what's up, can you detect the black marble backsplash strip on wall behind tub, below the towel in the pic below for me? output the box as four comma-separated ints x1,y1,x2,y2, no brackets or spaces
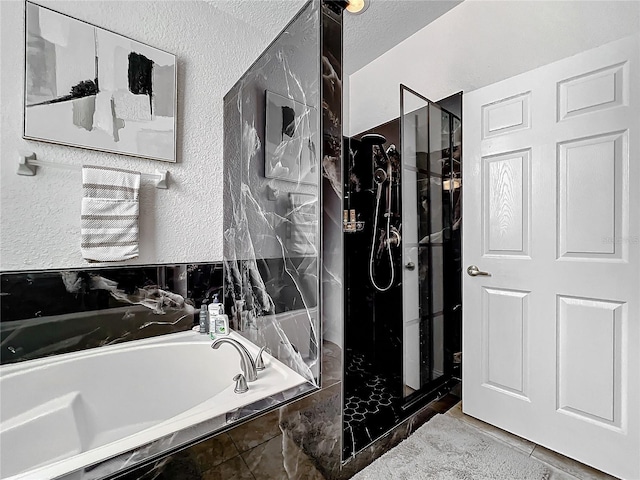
0,262,222,364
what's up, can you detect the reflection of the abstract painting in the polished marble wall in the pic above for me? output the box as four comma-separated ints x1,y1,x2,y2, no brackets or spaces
264,91,319,185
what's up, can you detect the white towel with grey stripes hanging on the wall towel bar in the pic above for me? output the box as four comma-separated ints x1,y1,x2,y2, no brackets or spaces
81,165,140,262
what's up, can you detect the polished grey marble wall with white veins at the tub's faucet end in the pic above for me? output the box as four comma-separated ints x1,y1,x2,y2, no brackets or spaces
224,2,322,384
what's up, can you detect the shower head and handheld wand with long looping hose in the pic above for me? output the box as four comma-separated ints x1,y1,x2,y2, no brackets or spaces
360,133,395,292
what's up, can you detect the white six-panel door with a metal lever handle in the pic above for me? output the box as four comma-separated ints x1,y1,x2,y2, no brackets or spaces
463,36,640,480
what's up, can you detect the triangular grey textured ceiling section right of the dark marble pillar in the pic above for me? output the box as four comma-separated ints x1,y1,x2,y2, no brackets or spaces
344,0,461,75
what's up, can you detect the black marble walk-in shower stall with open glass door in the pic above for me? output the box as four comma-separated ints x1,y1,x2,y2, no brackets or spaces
343,85,462,461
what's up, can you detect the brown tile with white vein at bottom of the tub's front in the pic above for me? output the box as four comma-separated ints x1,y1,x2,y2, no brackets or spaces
242,435,324,480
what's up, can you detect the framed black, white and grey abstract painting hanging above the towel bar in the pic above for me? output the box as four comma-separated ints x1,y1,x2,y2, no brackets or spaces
24,2,176,162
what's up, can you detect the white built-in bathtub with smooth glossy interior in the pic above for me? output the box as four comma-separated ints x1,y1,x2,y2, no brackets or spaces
0,332,306,480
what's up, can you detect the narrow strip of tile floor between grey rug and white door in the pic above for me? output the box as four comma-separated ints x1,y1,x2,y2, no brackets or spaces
445,403,616,480
